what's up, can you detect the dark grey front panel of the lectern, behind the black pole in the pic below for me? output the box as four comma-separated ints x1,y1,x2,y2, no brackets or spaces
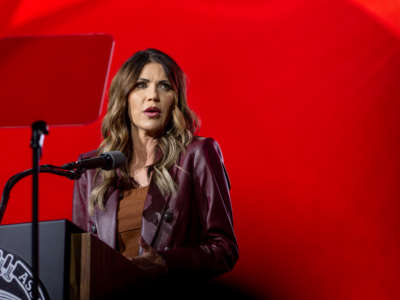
0,220,83,300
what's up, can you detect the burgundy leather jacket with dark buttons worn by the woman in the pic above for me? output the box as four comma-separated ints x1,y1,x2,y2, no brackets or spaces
72,137,238,275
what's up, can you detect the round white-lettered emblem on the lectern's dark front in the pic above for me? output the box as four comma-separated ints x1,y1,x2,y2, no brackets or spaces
0,249,48,300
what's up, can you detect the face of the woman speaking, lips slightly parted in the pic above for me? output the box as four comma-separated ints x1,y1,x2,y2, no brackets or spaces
128,62,175,136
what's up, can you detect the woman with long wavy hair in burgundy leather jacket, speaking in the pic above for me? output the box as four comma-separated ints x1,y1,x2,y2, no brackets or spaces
73,49,238,277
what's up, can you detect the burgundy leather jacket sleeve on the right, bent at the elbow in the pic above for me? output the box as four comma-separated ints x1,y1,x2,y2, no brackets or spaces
161,138,238,276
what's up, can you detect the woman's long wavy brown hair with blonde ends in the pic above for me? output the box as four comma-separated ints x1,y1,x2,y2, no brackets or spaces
89,49,199,214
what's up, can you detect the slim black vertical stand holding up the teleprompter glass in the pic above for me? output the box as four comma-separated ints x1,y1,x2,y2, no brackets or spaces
31,121,48,300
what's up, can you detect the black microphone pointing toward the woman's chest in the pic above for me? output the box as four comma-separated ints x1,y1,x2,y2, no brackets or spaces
61,151,126,170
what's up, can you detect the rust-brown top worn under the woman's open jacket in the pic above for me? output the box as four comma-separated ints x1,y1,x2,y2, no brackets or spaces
117,186,149,258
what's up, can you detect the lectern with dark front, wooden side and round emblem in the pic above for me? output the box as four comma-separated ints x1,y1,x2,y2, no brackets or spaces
0,220,147,300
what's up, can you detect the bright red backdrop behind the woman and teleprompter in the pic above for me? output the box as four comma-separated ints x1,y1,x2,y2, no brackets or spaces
0,0,400,299
